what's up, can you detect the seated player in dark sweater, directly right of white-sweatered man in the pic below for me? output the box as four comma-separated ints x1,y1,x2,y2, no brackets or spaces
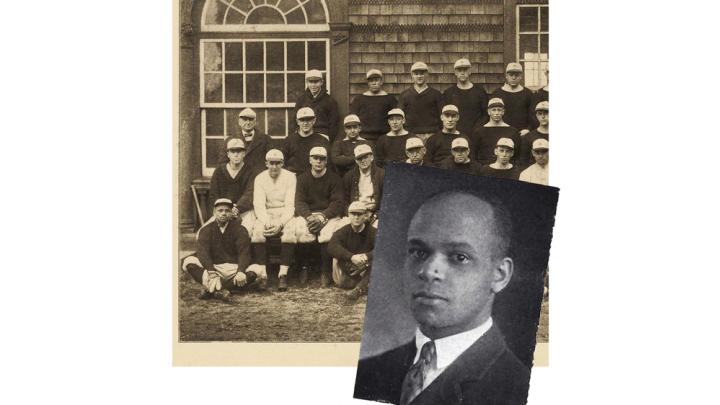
295,146,345,287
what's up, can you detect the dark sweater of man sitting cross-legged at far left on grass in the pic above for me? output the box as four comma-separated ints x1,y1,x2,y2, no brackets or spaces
197,220,252,271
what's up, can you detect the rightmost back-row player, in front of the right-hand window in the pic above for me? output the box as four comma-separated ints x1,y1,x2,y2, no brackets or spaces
492,62,533,135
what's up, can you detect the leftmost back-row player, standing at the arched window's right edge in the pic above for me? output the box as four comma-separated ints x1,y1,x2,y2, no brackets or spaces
293,69,340,142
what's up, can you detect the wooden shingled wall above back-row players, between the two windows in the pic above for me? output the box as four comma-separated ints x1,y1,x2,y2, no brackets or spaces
349,0,504,98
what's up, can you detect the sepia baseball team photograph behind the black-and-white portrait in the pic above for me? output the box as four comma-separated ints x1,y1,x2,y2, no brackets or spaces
174,0,554,354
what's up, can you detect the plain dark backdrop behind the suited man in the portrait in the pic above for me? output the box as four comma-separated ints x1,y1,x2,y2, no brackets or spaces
360,163,559,365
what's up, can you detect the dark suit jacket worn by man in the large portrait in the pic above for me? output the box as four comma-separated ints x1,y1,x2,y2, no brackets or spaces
354,326,530,405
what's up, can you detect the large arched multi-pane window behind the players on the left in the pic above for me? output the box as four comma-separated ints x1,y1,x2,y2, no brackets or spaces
199,0,330,176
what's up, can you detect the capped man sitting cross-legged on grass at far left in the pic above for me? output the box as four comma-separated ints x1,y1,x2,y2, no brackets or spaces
182,198,267,301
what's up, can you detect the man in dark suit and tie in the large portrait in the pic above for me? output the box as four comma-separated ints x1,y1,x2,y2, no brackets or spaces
355,191,530,405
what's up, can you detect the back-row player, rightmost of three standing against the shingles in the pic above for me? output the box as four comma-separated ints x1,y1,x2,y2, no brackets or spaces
443,58,488,135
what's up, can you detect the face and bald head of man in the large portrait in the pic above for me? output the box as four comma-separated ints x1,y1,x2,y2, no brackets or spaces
404,195,512,339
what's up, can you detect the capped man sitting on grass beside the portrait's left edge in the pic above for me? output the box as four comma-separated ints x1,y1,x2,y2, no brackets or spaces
328,201,377,303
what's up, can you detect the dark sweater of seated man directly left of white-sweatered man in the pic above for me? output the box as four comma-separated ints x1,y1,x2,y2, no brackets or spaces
207,164,258,213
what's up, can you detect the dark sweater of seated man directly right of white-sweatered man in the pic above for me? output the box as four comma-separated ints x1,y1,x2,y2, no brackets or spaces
295,170,345,219
